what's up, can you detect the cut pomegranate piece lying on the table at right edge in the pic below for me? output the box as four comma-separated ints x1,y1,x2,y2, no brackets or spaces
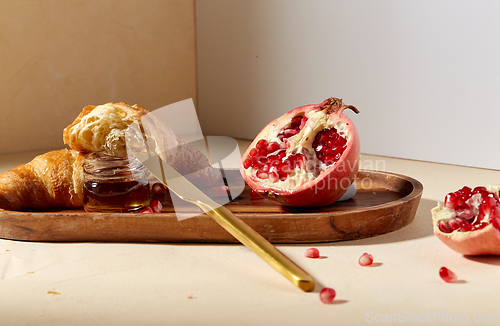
431,186,500,255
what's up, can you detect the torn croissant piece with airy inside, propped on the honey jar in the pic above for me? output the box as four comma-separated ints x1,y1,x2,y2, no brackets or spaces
63,102,222,187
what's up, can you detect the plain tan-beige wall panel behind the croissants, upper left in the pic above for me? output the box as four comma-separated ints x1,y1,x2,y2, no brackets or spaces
0,0,196,154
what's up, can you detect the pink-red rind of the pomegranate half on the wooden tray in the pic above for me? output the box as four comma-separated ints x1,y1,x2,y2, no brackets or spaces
240,99,360,207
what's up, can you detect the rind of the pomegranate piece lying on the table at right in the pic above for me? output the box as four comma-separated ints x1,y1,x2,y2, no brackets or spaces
431,195,500,256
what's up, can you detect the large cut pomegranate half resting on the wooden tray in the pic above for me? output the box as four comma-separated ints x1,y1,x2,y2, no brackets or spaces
240,98,360,207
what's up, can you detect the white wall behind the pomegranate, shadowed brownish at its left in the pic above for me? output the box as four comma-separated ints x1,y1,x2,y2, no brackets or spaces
196,0,500,171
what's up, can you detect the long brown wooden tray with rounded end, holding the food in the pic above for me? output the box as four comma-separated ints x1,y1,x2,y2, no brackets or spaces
0,170,423,243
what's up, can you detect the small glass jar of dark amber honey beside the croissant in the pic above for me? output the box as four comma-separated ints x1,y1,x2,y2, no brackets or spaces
83,152,151,212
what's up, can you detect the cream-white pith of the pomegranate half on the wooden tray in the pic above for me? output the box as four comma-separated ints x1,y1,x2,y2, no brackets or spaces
245,111,351,190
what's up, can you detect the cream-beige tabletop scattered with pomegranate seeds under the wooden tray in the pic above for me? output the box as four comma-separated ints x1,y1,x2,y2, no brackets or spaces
0,142,500,325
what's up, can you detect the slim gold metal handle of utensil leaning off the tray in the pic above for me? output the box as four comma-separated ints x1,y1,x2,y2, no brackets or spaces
193,201,315,292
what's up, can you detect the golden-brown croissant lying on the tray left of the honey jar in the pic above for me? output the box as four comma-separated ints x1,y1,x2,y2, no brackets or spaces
0,149,84,210
